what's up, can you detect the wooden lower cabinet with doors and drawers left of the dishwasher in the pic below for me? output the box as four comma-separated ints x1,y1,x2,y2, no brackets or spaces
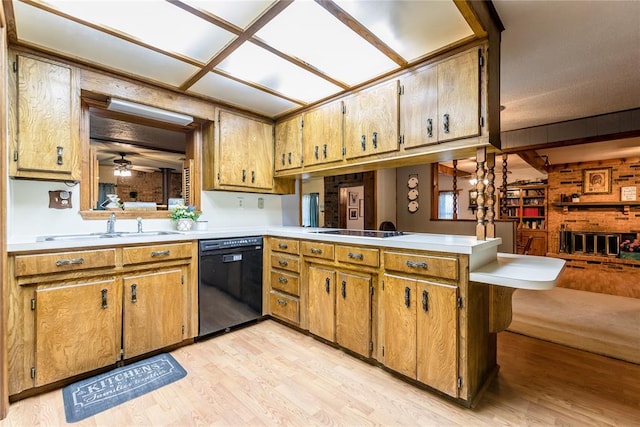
7,242,198,395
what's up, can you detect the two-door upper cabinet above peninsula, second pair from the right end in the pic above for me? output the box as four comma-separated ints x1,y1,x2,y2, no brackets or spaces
344,80,400,159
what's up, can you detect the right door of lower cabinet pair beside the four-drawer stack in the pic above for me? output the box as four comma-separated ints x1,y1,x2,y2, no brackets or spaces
336,272,371,357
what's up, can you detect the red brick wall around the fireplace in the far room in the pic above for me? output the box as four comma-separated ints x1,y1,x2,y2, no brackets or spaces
547,159,640,253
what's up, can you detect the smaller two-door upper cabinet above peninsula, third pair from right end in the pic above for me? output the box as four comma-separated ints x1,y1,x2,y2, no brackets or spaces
302,101,344,166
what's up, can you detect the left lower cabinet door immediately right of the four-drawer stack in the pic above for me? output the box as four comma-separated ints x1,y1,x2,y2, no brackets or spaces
308,265,336,342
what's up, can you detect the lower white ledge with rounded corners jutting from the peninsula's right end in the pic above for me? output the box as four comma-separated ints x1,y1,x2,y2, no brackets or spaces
469,253,565,290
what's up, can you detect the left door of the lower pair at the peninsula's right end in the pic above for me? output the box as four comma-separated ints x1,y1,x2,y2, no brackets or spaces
383,275,417,378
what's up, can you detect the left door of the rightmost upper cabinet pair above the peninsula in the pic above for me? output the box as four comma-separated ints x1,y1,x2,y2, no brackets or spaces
400,66,438,148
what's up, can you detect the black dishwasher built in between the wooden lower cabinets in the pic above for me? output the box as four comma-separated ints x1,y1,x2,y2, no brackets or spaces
198,236,262,338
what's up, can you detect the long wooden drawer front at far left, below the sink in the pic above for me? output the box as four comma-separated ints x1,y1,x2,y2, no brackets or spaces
15,249,116,277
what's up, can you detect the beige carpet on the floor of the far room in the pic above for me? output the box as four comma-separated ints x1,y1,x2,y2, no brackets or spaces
508,288,640,364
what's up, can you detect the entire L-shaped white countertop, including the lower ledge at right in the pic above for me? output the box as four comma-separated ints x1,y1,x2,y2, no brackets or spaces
7,226,564,289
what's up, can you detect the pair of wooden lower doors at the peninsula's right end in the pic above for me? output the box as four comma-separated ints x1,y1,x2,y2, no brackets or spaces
383,274,458,397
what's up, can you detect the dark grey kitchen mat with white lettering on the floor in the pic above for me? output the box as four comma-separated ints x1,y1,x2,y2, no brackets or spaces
62,353,187,423
